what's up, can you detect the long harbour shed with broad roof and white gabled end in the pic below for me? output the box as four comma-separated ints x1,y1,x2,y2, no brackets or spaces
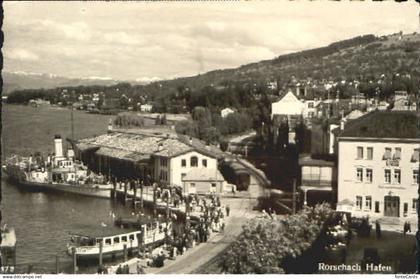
75,128,222,186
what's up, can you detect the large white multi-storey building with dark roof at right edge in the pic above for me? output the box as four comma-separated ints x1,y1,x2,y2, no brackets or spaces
337,111,420,222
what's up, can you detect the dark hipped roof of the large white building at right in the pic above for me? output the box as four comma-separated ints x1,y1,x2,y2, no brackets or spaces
339,111,420,139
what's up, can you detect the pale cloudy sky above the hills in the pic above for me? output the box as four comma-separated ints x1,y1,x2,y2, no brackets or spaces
2,0,420,82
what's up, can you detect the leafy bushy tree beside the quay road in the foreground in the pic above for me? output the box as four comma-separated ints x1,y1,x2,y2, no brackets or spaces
220,204,332,274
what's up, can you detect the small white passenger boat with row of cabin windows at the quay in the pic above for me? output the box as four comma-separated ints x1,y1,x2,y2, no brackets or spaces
67,219,172,261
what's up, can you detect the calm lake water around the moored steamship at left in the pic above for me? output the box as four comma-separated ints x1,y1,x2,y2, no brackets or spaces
0,105,146,273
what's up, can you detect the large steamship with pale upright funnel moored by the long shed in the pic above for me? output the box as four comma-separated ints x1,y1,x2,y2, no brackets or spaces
3,135,112,198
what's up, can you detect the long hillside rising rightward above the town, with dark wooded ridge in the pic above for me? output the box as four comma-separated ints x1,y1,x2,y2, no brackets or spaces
146,33,420,90
